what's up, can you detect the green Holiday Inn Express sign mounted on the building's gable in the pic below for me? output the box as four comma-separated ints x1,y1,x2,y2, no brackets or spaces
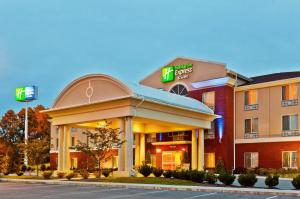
161,63,193,83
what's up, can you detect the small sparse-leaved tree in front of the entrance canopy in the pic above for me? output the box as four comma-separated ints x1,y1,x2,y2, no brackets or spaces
74,122,125,178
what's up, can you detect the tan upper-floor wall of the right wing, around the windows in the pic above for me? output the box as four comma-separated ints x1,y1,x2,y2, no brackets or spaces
236,83,300,139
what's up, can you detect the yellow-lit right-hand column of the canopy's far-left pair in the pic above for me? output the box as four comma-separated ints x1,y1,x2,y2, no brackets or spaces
63,126,71,171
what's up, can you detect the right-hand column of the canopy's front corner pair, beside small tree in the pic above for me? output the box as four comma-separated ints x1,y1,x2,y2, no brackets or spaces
125,117,133,171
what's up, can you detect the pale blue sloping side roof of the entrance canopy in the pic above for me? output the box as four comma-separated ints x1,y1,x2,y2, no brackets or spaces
122,81,214,114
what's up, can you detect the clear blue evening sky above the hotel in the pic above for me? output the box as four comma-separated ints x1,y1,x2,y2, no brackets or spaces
0,0,300,116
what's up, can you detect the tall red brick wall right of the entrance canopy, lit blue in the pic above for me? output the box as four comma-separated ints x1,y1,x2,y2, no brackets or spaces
189,85,234,169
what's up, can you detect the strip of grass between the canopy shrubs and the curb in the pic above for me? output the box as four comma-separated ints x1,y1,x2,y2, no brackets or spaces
81,177,203,186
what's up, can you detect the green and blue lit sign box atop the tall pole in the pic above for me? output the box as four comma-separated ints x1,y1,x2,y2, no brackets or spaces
16,86,37,102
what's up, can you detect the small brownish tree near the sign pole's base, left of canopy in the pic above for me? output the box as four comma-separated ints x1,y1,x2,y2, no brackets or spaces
18,138,50,176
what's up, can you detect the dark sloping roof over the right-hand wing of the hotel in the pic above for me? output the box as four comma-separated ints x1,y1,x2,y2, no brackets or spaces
245,71,300,85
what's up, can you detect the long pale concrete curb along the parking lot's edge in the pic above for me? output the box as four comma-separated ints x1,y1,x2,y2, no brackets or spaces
0,178,300,196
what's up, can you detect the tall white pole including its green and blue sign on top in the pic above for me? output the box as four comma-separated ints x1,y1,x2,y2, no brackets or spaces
15,86,37,166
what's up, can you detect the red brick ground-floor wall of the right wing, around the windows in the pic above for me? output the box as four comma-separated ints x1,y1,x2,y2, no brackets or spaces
236,141,300,169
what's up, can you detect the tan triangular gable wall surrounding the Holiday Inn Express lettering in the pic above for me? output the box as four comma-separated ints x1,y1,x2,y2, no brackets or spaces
140,58,227,91
